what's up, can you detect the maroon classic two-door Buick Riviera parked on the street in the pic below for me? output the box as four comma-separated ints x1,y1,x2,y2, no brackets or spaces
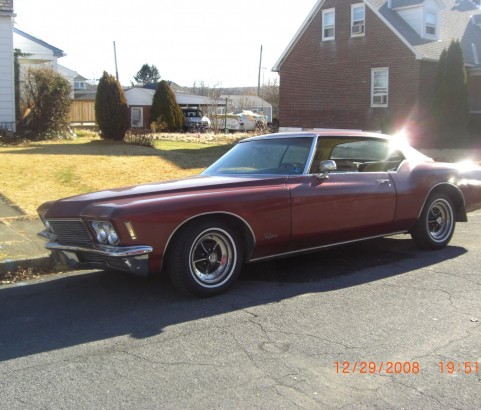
38,130,481,296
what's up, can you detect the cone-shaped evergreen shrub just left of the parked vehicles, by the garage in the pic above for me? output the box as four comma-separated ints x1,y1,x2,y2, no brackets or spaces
152,80,184,131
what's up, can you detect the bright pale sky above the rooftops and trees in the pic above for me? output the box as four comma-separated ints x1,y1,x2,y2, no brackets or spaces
14,0,317,87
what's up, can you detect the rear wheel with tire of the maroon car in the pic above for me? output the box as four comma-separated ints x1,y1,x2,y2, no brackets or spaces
411,194,456,249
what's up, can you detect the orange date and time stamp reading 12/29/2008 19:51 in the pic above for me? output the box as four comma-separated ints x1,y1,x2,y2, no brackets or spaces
334,361,479,374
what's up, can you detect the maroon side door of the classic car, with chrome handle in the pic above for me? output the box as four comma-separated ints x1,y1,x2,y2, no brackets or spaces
288,138,396,250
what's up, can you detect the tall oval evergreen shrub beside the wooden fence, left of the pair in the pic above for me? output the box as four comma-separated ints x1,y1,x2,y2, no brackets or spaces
95,71,129,140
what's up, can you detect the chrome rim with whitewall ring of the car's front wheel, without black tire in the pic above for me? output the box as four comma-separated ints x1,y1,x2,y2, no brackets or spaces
189,229,237,286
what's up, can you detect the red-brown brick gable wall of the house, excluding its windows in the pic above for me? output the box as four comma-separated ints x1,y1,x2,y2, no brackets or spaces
279,0,436,139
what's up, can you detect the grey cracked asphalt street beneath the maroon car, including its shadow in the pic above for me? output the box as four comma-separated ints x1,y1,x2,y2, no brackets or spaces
0,211,481,409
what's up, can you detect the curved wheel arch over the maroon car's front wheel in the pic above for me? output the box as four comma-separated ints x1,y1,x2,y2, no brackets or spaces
164,213,255,260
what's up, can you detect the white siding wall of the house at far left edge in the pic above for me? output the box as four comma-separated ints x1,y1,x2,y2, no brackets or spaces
0,0,15,133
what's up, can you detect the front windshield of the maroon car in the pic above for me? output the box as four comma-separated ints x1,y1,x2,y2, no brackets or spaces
202,137,313,175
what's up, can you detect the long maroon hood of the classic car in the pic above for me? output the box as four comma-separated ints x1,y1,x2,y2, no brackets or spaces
38,176,286,218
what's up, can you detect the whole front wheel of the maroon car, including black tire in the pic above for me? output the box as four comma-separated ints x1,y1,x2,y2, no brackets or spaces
167,221,242,296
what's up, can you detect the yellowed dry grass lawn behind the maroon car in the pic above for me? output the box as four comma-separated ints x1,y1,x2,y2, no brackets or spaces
0,135,236,216
